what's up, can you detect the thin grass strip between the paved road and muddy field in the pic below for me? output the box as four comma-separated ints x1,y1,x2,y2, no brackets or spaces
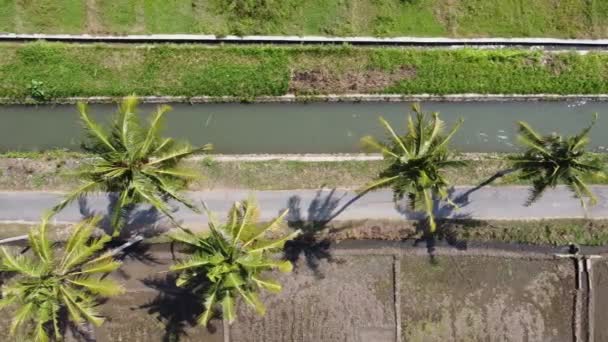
0,219,608,247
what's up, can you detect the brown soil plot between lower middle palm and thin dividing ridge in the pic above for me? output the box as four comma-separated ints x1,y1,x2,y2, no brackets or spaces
230,255,395,342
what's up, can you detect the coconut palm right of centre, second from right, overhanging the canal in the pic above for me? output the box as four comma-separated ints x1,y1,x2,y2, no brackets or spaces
360,104,464,232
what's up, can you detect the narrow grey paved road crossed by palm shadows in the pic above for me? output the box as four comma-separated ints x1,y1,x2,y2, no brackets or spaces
0,186,608,225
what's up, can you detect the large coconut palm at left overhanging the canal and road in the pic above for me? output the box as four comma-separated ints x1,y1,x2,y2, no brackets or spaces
53,96,211,236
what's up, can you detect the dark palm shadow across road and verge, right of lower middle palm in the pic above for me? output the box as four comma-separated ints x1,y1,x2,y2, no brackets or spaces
284,189,353,278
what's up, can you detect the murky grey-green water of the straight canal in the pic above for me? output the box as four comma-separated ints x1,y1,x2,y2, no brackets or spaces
0,101,608,154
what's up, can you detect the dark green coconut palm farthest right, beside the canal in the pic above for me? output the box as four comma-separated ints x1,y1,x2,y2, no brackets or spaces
510,114,605,208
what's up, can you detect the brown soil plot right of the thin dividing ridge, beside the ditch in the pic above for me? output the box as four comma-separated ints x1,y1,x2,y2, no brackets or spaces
400,256,575,342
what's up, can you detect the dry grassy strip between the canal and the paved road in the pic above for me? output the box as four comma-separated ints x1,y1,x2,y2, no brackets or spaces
0,151,608,191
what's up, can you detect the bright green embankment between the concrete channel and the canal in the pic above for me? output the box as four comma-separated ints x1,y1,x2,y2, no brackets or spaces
0,43,608,100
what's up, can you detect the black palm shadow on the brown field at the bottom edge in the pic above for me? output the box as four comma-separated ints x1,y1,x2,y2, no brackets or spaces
136,274,218,342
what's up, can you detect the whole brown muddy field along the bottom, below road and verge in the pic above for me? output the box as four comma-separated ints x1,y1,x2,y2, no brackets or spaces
2,243,592,342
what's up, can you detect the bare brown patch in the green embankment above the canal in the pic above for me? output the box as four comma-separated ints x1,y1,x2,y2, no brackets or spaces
289,67,416,94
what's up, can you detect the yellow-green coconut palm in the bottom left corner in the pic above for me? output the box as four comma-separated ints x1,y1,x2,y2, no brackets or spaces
0,218,123,341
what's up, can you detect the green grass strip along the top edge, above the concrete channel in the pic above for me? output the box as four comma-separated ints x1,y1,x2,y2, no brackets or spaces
0,0,608,37
